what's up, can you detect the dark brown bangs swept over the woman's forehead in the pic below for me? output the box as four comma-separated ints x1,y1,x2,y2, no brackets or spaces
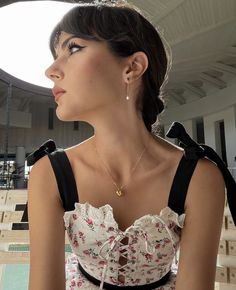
49,4,143,58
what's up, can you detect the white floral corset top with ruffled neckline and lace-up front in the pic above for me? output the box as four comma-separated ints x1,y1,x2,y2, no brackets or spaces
64,203,185,289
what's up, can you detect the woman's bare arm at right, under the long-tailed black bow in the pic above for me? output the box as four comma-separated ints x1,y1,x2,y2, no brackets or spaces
176,159,225,290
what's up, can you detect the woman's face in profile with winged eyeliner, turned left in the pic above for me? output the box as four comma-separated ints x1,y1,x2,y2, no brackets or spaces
46,32,126,121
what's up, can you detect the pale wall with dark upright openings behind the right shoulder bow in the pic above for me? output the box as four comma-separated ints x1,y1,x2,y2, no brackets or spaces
161,81,236,167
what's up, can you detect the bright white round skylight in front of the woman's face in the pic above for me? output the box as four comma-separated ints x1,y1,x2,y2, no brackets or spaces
0,1,76,88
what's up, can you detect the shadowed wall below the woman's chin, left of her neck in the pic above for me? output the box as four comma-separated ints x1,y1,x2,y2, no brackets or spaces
0,103,93,153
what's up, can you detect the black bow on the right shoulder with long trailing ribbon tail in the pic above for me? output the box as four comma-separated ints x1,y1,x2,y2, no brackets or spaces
166,122,236,225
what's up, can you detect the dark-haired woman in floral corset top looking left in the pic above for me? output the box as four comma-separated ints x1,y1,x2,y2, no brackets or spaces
28,4,225,290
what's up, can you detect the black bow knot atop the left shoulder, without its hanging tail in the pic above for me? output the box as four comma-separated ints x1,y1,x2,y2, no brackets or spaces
27,139,56,166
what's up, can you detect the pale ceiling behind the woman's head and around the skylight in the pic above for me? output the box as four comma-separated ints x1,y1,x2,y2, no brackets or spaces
0,0,236,110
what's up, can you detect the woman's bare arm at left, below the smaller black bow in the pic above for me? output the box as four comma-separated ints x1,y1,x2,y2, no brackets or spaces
28,156,65,290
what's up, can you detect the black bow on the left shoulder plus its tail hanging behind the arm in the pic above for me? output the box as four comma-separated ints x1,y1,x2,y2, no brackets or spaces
21,139,56,222
